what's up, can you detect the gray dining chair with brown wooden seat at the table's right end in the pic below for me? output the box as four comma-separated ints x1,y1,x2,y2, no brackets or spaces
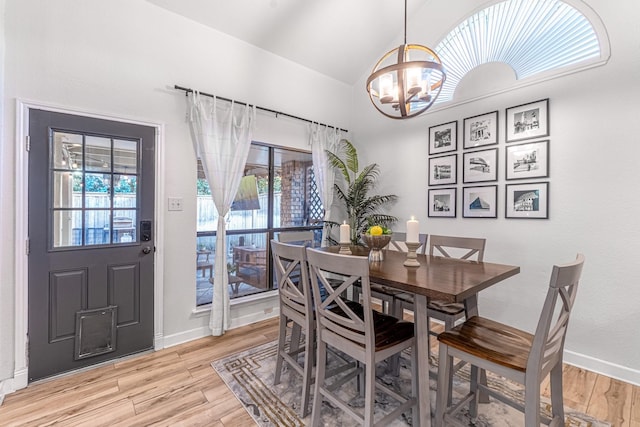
435,254,584,427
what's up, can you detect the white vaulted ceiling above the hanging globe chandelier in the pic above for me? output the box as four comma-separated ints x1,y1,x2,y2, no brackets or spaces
147,0,429,85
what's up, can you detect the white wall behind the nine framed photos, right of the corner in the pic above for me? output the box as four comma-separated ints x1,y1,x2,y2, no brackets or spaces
351,0,640,384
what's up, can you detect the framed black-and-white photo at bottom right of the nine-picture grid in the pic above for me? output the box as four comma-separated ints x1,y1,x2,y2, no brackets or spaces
505,182,549,219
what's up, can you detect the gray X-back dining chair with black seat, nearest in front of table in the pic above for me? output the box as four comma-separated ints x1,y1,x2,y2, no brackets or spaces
307,248,417,426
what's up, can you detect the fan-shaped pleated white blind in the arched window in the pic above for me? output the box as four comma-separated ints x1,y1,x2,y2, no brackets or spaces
435,0,601,103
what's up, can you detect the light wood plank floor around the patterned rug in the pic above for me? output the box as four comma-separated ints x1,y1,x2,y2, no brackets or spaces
0,319,640,427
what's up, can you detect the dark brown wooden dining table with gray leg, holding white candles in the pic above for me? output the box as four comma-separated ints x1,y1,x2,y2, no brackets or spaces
325,246,520,426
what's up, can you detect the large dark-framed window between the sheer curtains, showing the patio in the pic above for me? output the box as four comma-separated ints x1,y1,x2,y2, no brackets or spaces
196,143,324,305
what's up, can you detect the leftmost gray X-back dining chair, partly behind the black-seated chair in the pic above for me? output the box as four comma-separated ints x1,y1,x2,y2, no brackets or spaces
271,240,316,418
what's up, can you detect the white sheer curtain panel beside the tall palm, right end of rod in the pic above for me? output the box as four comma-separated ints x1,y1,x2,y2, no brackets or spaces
309,123,342,246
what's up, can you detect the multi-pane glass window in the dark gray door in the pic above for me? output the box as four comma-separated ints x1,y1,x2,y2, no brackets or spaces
50,130,139,248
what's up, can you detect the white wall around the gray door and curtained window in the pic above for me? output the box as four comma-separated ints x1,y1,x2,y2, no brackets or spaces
0,0,351,386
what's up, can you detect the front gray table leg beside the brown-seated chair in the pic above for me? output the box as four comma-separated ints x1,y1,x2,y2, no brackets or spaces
413,294,431,427
